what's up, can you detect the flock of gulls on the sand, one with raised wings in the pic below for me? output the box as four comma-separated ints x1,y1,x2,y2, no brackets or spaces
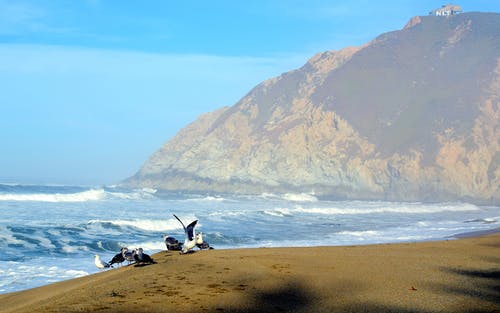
94,214,213,270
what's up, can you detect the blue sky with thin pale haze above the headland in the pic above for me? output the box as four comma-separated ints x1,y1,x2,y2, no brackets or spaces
0,0,500,186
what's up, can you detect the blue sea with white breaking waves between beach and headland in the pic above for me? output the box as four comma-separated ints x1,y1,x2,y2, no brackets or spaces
0,184,500,293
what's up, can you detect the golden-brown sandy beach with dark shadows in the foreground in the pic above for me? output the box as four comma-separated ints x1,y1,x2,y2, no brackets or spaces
0,233,500,313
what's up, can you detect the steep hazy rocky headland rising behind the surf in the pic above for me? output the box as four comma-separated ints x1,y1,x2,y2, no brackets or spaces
125,13,500,204
